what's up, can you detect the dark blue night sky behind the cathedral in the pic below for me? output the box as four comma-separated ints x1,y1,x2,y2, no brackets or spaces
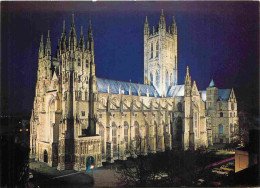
1,1,259,115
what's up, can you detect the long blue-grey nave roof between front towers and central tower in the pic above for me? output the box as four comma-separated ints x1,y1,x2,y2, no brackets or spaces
97,78,159,97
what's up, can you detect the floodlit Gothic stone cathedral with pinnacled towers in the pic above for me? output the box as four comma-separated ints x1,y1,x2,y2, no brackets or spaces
30,11,238,171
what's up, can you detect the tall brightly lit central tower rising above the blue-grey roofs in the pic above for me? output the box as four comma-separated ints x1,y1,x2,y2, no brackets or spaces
144,10,178,97
